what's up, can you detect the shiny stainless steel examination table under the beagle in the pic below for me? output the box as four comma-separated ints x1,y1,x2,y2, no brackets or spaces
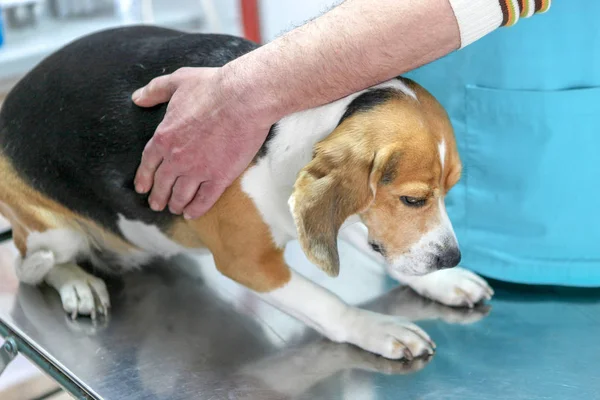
0,233,600,400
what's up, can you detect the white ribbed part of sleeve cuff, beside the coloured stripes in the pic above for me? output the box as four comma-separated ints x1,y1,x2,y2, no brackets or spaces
450,0,504,49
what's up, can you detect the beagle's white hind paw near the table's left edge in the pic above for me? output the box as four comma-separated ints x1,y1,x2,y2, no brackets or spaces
46,264,110,319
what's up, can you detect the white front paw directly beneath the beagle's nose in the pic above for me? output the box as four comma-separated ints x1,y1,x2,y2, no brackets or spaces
399,267,494,308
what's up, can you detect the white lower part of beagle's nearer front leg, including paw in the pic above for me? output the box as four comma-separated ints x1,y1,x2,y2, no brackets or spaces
262,272,435,359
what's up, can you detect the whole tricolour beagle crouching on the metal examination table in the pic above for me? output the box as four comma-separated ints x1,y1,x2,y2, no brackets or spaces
0,26,492,359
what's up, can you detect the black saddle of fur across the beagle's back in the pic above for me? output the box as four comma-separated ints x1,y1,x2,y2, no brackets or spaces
0,26,258,234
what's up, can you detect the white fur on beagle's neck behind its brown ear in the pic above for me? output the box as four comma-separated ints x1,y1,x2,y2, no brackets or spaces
242,79,416,247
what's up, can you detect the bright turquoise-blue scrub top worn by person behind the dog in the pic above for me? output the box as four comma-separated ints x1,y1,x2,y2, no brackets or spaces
407,0,600,286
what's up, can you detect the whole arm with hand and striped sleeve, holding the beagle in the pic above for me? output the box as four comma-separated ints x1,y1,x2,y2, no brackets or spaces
133,0,549,218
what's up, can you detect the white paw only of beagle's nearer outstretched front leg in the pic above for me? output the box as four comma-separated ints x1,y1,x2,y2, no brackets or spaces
346,308,435,360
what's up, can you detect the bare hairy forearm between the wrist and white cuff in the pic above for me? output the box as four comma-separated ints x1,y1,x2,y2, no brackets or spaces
224,0,460,122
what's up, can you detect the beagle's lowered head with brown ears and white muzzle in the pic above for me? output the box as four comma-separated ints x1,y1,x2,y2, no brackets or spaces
290,80,461,276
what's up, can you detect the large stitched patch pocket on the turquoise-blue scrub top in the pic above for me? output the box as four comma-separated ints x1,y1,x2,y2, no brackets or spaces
460,86,600,286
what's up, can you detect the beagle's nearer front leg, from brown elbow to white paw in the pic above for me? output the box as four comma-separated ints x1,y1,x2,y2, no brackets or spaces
213,244,434,359
